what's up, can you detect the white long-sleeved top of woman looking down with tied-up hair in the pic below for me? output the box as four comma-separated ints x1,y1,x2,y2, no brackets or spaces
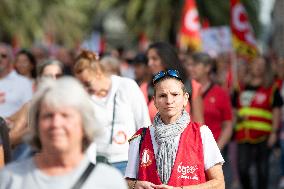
88,76,151,163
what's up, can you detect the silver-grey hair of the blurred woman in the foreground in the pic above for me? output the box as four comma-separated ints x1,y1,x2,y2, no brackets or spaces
29,77,99,151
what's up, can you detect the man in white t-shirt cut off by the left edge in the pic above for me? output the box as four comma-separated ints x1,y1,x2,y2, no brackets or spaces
0,43,32,118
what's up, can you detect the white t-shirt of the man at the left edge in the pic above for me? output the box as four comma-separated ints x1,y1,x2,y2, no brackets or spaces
0,71,33,117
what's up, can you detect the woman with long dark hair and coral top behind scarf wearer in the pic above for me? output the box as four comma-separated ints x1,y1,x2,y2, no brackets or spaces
140,42,204,123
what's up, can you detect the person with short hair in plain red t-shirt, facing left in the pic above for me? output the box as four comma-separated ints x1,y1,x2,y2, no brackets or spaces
187,53,233,150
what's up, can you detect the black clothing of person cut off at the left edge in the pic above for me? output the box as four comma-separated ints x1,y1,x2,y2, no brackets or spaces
0,117,11,164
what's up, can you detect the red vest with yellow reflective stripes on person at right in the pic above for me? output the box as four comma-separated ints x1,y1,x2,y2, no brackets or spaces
235,86,275,143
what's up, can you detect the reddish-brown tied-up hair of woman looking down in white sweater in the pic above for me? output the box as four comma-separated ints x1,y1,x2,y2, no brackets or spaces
74,50,106,74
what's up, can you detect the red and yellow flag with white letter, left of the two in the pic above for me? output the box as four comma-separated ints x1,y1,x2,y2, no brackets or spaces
179,0,201,50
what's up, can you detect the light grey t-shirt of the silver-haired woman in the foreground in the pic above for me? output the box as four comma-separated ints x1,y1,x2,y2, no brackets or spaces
0,157,127,189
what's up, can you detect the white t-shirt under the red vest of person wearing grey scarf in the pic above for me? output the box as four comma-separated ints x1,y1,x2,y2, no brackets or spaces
125,125,224,178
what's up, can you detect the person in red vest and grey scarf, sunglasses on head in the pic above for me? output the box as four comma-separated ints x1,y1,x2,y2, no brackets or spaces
125,70,225,189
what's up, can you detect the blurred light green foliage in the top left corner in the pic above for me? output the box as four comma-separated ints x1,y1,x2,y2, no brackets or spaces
0,0,96,46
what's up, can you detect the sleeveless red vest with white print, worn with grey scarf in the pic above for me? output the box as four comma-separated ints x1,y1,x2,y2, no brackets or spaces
137,123,206,187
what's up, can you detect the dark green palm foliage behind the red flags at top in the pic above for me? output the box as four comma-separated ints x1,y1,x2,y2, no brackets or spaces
96,0,261,41
